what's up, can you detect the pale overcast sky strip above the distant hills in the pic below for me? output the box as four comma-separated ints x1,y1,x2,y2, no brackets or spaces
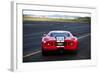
23,10,90,17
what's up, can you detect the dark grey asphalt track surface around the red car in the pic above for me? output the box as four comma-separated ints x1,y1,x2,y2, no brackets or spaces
23,21,91,62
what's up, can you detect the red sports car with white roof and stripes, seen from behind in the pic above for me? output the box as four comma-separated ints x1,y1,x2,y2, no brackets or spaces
42,30,78,55
